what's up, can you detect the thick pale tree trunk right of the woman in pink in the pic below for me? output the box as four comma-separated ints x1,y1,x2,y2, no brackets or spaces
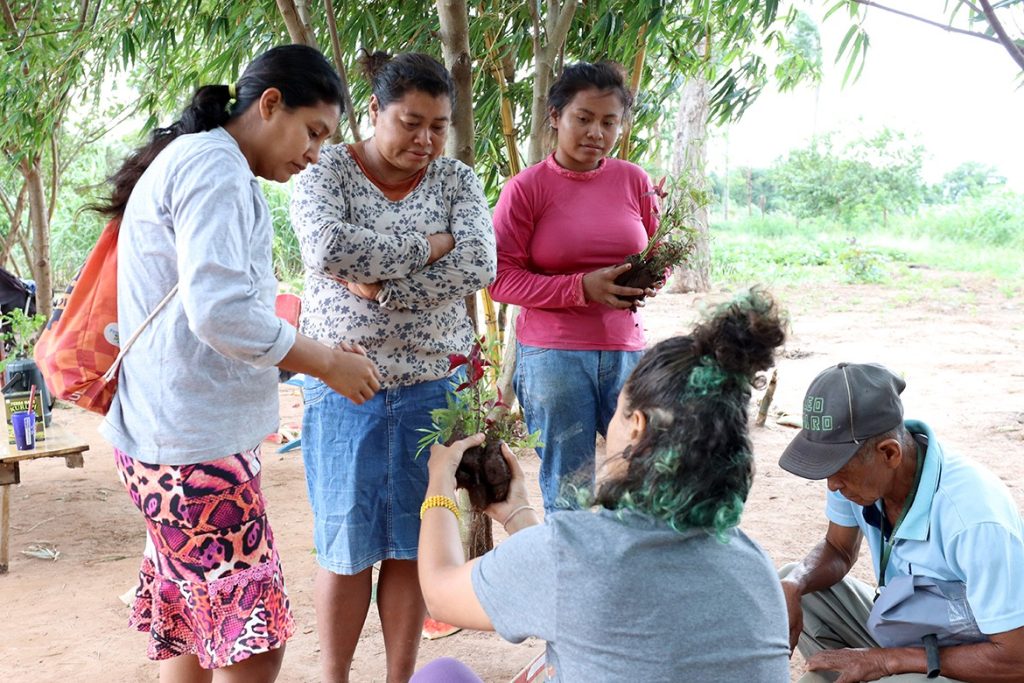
670,70,708,292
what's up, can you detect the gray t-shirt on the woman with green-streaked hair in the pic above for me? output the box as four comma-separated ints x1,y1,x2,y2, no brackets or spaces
472,510,790,683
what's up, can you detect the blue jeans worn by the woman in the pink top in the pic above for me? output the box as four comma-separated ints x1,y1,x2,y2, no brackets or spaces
513,344,643,514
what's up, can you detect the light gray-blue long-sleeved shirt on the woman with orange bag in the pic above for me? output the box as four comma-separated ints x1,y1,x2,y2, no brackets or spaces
100,128,295,465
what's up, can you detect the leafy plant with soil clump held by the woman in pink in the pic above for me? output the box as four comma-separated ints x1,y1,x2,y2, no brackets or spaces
615,177,708,310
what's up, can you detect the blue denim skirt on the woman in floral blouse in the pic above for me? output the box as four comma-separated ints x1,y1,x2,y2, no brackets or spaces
302,376,453,574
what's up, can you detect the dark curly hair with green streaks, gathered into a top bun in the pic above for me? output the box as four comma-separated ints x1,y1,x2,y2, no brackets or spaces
581,289,785,539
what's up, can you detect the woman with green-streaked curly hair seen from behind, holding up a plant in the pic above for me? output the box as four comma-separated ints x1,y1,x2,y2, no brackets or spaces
414,289,790,683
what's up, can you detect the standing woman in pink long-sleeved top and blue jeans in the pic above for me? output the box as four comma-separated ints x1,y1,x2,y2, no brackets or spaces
489,62,657,513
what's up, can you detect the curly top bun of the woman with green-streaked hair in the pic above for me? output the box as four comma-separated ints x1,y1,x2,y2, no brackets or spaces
693,287,786,378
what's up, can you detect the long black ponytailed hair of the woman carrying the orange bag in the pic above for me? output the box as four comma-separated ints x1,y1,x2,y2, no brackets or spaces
92,45,344,218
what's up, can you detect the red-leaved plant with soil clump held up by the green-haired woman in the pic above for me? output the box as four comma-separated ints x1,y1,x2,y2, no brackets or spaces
417,338,542,512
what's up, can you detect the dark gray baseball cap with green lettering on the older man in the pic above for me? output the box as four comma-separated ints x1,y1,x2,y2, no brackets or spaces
778,362,906,479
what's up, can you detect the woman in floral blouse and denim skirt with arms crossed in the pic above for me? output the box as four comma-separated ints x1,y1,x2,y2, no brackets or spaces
292,52,497,681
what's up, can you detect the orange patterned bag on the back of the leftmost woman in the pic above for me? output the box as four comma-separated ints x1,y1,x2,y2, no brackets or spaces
35,219,178,415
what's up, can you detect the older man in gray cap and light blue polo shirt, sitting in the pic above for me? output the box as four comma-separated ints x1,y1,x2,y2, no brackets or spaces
779,362,1024,683
